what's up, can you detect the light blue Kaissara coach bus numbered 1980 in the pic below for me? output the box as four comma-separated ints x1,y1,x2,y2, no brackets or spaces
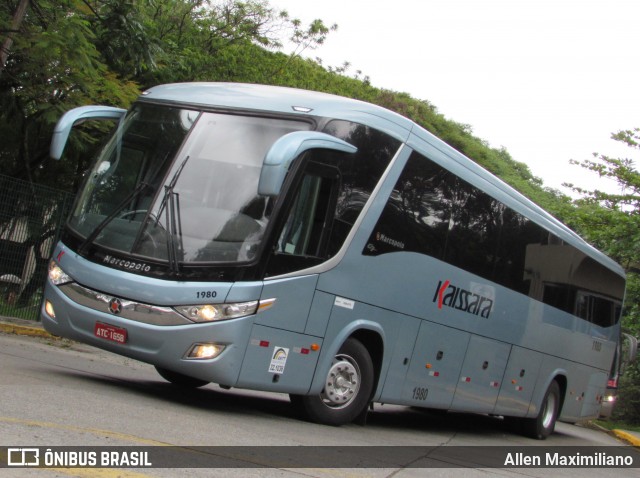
42,83,625,439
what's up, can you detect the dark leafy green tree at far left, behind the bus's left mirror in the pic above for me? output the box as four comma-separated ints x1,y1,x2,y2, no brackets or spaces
0,0,137,186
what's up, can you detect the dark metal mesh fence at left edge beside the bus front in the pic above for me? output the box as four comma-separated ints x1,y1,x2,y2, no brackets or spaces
0,175,73,320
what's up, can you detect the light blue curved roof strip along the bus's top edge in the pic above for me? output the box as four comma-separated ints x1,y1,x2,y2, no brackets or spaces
140,82,625,277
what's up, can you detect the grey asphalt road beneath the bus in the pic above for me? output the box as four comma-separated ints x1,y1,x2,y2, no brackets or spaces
0,334,640,478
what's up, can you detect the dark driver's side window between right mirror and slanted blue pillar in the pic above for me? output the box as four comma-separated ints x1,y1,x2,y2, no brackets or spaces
266,120,400,276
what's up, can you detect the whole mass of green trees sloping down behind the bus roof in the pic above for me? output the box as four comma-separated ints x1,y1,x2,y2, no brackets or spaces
0,0,562,206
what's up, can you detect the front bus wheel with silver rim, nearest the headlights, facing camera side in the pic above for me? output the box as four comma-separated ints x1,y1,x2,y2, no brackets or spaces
291,338,374,426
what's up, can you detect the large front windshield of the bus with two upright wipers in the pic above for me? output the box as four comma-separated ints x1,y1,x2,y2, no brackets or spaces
69,104,309,265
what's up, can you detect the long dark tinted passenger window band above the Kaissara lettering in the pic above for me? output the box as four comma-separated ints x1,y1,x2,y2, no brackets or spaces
363,153,624,327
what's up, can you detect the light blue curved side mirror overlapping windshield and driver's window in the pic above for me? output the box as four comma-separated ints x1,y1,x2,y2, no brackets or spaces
258,131,358,196
